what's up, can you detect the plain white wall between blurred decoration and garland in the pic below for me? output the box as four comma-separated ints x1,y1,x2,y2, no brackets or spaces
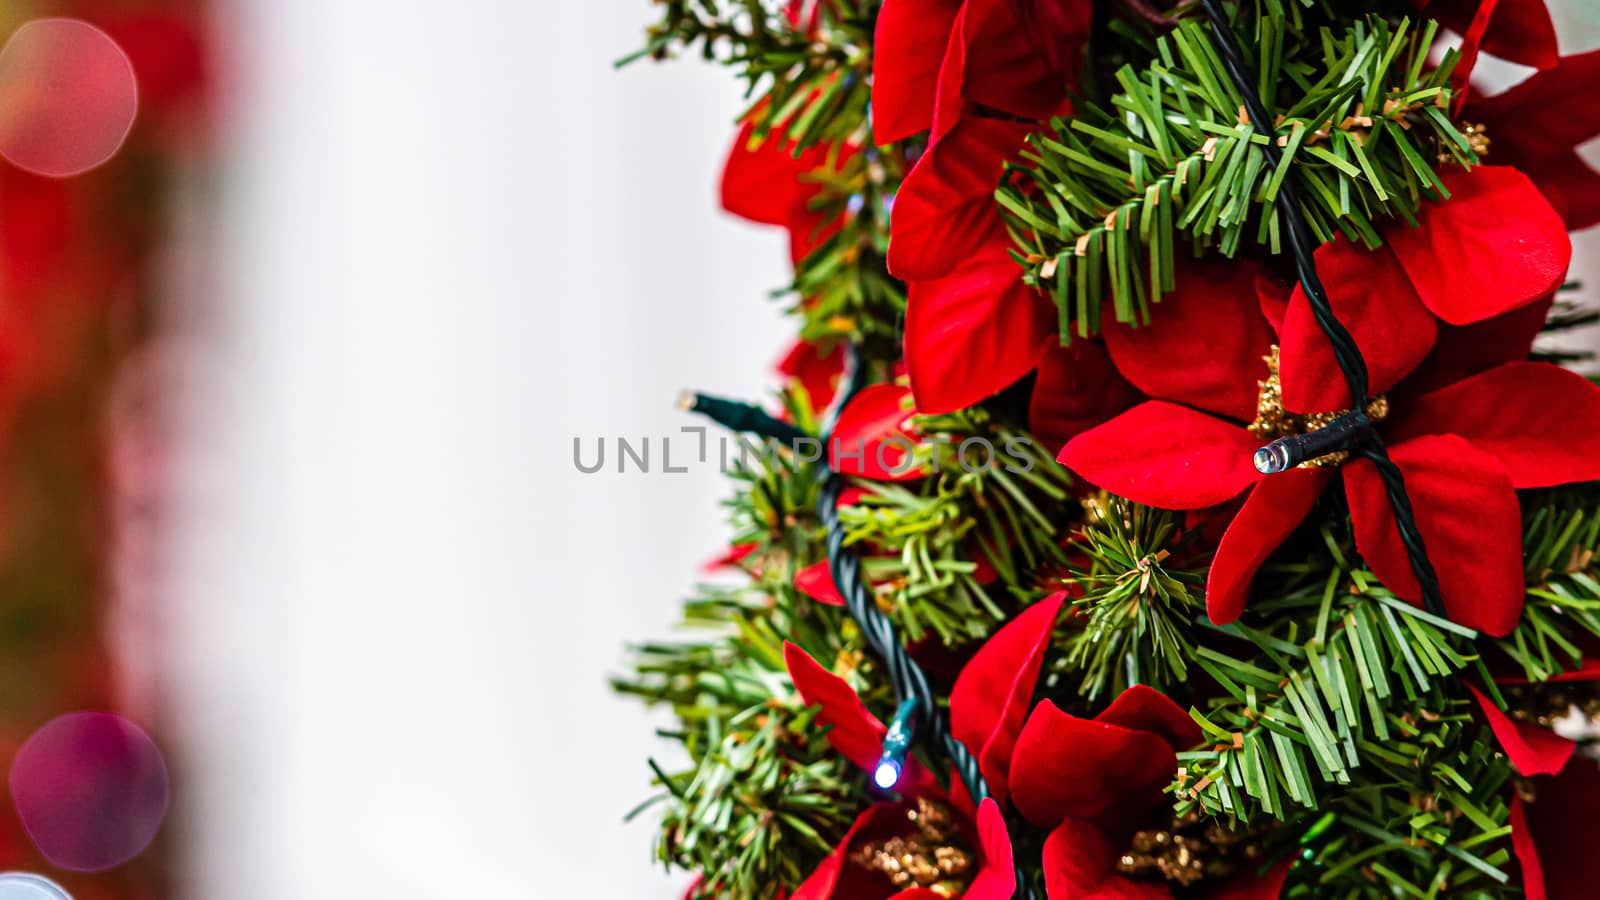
162,0,1600,900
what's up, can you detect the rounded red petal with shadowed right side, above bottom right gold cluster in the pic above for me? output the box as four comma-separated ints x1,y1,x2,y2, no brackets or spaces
1011,700,1178,828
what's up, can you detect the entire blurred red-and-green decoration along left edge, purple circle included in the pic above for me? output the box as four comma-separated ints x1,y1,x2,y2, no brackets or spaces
0,0,210,900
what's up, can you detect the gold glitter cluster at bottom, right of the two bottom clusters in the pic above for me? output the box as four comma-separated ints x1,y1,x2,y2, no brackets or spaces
1117,812,1261,887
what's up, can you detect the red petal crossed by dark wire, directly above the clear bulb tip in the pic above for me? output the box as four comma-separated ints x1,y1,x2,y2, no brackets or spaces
1278,239,1443,413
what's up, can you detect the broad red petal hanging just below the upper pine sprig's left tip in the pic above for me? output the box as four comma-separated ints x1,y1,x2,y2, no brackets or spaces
906,231,1054,413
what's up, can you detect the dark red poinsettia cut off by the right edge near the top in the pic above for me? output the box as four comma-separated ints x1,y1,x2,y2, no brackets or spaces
1461,50,1600,231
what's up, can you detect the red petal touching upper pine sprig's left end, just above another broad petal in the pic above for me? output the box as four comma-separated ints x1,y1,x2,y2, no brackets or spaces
888,117,1032,282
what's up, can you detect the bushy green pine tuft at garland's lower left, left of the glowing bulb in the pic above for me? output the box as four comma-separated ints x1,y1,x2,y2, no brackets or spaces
613,589,883,900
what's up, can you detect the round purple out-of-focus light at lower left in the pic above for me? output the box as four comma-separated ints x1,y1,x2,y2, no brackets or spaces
11,713,170,871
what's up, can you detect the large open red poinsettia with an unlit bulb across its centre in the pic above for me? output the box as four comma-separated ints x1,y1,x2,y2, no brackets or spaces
1061,168,1600,634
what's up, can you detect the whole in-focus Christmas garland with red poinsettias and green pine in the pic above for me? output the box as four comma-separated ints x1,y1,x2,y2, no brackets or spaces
616,0,1600,900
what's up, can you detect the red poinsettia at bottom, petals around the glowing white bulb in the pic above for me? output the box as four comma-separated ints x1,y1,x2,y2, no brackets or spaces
784,644,1016,900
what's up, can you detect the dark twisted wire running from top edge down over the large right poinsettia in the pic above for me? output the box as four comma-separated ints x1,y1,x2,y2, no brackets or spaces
1202,0,1445,618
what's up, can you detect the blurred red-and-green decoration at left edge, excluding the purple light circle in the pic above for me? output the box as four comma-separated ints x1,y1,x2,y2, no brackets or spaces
0,0,214,900
